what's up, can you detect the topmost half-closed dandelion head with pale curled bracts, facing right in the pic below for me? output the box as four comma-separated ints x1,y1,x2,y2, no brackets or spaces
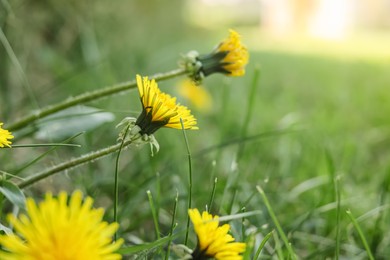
183,30,249,82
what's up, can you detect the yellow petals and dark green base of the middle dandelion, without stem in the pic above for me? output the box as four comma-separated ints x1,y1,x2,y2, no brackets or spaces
135,75,198,135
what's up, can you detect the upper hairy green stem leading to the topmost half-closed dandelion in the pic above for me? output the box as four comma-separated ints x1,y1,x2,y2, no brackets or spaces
7,69,186,131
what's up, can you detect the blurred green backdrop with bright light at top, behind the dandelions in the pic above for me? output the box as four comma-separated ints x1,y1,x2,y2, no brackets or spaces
0,0,390,259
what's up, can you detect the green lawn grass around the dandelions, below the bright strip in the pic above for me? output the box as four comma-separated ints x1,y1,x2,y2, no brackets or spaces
0,1,390,259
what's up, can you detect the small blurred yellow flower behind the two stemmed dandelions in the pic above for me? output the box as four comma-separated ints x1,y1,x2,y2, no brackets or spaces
178,79,212,112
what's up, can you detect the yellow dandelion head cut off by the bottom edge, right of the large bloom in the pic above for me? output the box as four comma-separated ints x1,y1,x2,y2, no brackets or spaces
188,209,246,260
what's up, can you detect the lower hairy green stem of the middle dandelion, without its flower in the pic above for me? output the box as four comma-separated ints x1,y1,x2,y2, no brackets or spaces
18,140,132,189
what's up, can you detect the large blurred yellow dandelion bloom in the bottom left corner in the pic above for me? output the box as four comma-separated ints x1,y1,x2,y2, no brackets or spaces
0,191,122,260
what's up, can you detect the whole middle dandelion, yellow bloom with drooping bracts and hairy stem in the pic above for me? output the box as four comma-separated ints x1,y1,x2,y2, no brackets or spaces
18,75,198,188
